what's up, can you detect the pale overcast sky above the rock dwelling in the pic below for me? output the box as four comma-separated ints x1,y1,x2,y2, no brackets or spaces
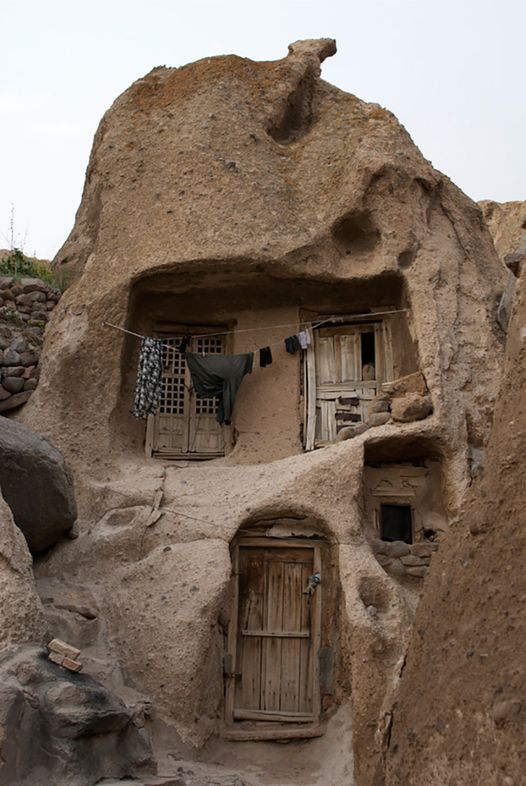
0,0,526,258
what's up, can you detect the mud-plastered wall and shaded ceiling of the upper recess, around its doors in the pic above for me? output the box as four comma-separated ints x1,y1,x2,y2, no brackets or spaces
113,272,418,462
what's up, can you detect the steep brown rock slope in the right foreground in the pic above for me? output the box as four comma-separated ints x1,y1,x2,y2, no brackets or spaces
386,273,526,786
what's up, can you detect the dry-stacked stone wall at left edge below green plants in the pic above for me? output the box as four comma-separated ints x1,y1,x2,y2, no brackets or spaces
0,276,60,412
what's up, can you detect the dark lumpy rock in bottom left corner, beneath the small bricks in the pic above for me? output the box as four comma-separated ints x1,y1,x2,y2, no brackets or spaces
0,646,151,786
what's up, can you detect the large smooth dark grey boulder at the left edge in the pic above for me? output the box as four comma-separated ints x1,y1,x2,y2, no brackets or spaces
0,417,77,552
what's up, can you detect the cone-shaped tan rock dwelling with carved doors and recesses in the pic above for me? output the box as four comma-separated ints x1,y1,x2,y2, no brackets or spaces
0,39,520,786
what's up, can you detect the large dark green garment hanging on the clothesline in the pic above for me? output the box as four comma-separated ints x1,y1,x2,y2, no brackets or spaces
186,352,254,426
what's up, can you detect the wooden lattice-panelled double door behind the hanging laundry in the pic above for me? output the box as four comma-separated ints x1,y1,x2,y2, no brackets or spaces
146,328,225,458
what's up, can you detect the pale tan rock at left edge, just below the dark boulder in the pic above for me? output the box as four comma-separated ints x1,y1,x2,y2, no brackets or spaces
0,494,45,650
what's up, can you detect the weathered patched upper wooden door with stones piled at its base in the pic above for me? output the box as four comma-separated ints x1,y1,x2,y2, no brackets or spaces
305,322,389,450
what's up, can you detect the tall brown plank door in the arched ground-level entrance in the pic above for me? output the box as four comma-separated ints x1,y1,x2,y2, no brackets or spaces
227,544,321,724
